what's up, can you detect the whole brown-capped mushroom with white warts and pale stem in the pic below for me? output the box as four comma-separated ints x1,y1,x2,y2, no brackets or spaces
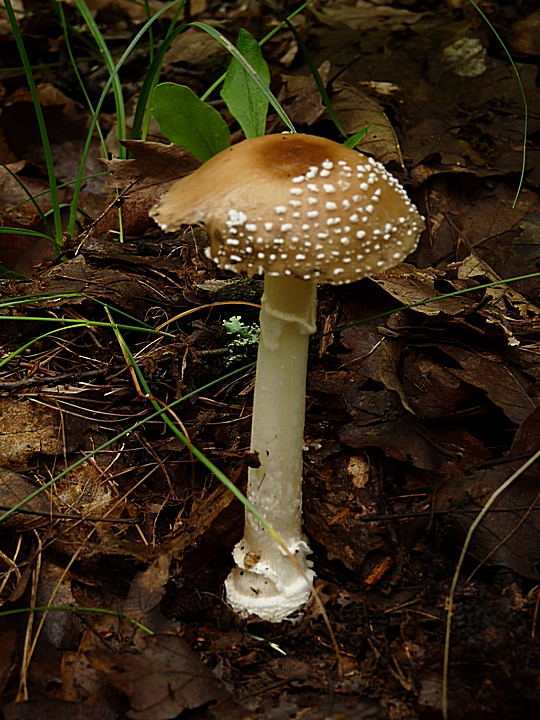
151,134,424,622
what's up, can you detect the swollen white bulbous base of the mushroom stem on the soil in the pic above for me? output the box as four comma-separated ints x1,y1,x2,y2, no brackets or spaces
225,540,315,622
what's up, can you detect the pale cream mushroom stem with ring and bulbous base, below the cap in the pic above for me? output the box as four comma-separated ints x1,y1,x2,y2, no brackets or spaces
225,274,317,622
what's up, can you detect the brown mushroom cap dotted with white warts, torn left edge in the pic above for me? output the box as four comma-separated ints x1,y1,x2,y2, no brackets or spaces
151,134,424,284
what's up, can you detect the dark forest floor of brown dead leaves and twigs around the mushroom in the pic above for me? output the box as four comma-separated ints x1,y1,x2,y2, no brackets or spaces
0,0,540,720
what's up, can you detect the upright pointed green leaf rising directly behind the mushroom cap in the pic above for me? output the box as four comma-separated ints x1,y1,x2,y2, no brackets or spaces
221,28,270,138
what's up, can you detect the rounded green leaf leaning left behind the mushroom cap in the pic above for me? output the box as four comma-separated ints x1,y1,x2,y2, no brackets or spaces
152,83,231,162
